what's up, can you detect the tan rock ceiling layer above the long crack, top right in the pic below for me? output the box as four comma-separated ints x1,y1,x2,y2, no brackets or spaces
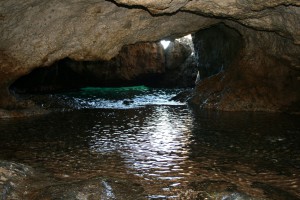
115,0,300,44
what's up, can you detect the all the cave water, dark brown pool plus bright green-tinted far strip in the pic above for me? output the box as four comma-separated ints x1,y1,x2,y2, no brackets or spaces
0,87,300,200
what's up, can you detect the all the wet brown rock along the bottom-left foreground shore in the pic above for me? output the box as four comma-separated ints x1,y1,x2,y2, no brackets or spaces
0,160,145,200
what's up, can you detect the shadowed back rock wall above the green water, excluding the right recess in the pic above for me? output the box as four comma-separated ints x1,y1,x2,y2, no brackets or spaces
11,41,197,93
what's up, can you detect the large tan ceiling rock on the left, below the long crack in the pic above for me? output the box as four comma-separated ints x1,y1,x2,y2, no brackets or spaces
0,0,217,107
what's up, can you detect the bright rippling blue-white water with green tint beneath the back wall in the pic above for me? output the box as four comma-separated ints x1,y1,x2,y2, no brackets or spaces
63,86,184,109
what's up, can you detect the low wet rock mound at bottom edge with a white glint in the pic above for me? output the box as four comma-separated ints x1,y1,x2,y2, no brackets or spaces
30,179,145,200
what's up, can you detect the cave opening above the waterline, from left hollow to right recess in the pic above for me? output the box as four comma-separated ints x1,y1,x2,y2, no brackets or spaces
10,23,242,97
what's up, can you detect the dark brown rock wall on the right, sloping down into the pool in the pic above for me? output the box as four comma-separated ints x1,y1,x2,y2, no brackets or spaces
191,24,300,112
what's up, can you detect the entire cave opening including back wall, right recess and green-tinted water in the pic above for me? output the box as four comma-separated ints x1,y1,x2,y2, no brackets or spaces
10,23,243,111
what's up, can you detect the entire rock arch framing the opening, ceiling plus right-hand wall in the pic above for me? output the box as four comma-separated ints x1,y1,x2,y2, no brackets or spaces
0,0,300,111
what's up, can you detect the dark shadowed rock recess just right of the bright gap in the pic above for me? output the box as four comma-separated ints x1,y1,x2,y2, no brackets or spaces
193,24,242,80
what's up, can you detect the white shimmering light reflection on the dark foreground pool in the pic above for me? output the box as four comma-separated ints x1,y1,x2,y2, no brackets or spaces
89,106,192,183
